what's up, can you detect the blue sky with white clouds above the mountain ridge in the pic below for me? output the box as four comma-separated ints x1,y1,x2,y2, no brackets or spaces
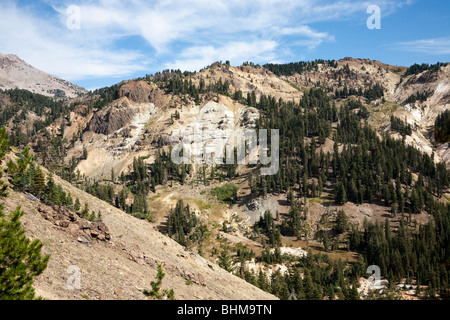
0,0,450,89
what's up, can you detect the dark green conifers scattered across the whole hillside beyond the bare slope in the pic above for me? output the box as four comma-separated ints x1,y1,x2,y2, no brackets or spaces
0,60,450,299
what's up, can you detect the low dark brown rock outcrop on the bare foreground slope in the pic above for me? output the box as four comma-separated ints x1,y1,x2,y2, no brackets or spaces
38,205,111,243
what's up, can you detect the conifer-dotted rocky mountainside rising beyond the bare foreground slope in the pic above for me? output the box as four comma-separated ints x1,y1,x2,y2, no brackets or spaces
0,58,450,299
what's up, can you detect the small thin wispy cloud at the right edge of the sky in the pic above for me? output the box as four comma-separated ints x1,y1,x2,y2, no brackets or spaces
393,38,450,56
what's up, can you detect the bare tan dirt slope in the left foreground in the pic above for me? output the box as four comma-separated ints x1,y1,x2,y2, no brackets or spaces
0,168,276,299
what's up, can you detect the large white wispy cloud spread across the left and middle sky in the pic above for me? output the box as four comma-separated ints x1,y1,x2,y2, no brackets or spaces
0,0,410,80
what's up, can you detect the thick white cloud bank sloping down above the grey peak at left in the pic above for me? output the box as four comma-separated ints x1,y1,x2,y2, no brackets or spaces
0,2,144,81
